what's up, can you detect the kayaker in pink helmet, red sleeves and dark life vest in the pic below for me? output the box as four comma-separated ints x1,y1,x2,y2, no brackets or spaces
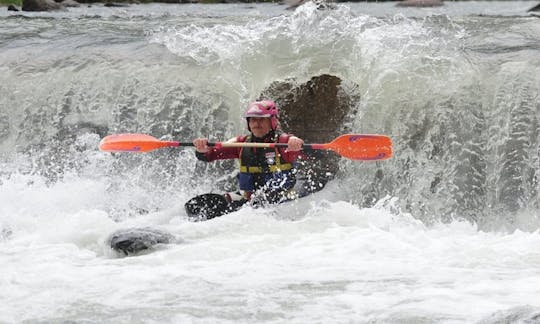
193,100,304,206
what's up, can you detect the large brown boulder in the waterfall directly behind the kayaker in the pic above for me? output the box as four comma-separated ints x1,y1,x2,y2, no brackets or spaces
261,75,360,191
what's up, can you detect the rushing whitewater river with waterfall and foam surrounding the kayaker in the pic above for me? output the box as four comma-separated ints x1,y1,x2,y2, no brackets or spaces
0,1,540,323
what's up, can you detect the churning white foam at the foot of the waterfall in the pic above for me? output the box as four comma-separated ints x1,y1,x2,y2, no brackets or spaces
0,170,540,323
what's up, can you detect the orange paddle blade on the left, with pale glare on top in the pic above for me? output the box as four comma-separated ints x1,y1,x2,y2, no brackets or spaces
99,134,179,152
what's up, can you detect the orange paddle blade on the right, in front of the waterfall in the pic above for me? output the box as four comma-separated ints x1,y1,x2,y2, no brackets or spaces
324,134,392,160
